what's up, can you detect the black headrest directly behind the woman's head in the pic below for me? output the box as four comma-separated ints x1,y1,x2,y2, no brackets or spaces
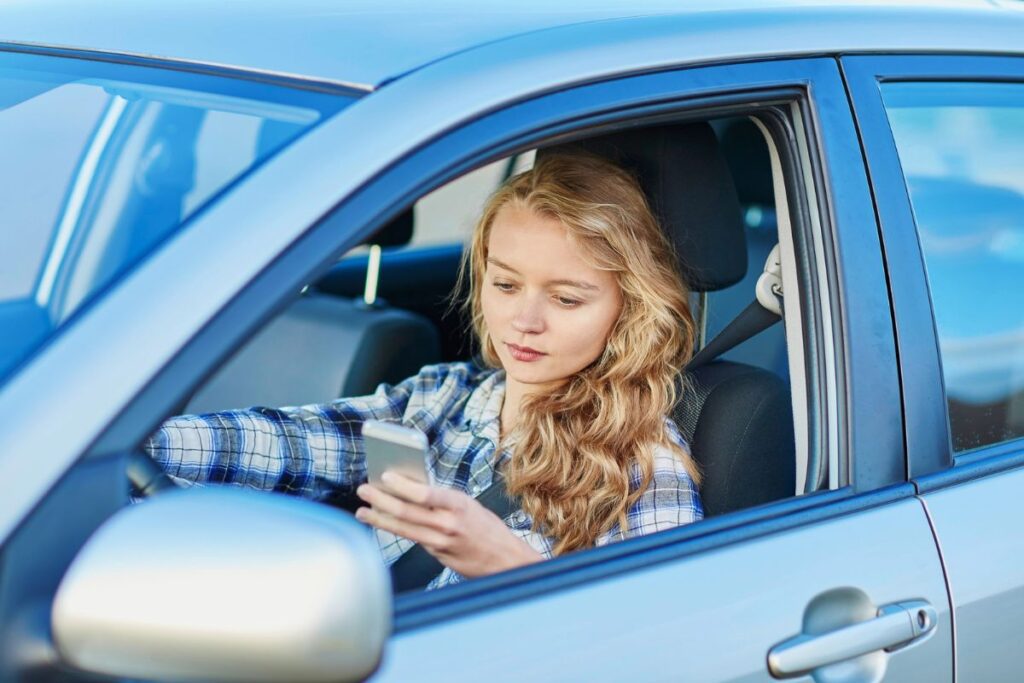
537,122,746,292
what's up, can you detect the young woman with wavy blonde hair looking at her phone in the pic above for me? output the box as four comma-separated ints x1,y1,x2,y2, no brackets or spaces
146,153,702,588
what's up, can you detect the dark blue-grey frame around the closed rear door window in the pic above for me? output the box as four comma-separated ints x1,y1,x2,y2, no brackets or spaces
841,54,1024,493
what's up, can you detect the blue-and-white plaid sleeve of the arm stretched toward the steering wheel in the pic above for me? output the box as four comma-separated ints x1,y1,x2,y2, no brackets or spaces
142,376,427,498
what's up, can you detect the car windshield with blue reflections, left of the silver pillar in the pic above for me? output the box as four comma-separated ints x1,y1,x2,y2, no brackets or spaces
0,52,351,383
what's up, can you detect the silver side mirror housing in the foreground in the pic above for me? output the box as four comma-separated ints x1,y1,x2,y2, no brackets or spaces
51,487,391,683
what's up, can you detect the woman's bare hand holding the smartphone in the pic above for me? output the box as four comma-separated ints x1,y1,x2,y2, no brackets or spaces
355,472,544,578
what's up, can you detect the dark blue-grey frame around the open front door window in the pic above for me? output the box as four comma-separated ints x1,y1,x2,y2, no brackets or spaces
90,57,913,632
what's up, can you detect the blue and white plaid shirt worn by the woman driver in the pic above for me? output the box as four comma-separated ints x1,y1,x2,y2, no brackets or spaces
144,362,703,588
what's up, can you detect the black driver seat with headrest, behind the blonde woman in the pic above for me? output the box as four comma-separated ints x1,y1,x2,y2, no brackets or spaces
538,122,796,517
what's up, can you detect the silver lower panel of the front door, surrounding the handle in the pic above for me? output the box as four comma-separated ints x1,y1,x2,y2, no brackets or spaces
371,500,952,683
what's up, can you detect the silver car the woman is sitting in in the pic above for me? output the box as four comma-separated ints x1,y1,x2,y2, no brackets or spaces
0,0,1024,683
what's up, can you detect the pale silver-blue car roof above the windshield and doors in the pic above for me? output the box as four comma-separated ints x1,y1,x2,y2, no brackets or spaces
0,0,1024,90
